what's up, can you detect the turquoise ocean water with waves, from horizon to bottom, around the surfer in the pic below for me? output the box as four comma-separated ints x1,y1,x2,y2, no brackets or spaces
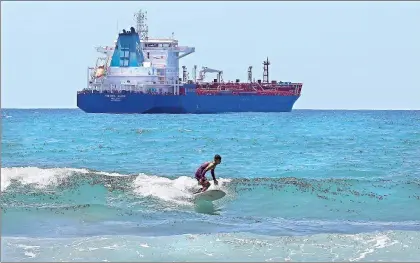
1,109,420,262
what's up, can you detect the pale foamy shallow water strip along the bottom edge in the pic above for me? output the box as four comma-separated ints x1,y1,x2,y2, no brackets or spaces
2,231,420,262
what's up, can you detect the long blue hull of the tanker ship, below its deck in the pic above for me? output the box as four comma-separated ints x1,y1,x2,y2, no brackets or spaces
77,93,299,114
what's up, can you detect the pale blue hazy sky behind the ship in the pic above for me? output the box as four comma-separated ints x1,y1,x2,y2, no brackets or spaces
1,1,420,109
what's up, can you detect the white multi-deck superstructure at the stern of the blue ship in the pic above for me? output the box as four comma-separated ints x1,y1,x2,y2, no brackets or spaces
88,11,195,95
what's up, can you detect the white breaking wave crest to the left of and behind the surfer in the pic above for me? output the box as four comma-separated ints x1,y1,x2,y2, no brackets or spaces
1,167,230,205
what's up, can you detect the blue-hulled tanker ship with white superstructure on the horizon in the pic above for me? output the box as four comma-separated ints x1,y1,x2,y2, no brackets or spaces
77,10,302,114
